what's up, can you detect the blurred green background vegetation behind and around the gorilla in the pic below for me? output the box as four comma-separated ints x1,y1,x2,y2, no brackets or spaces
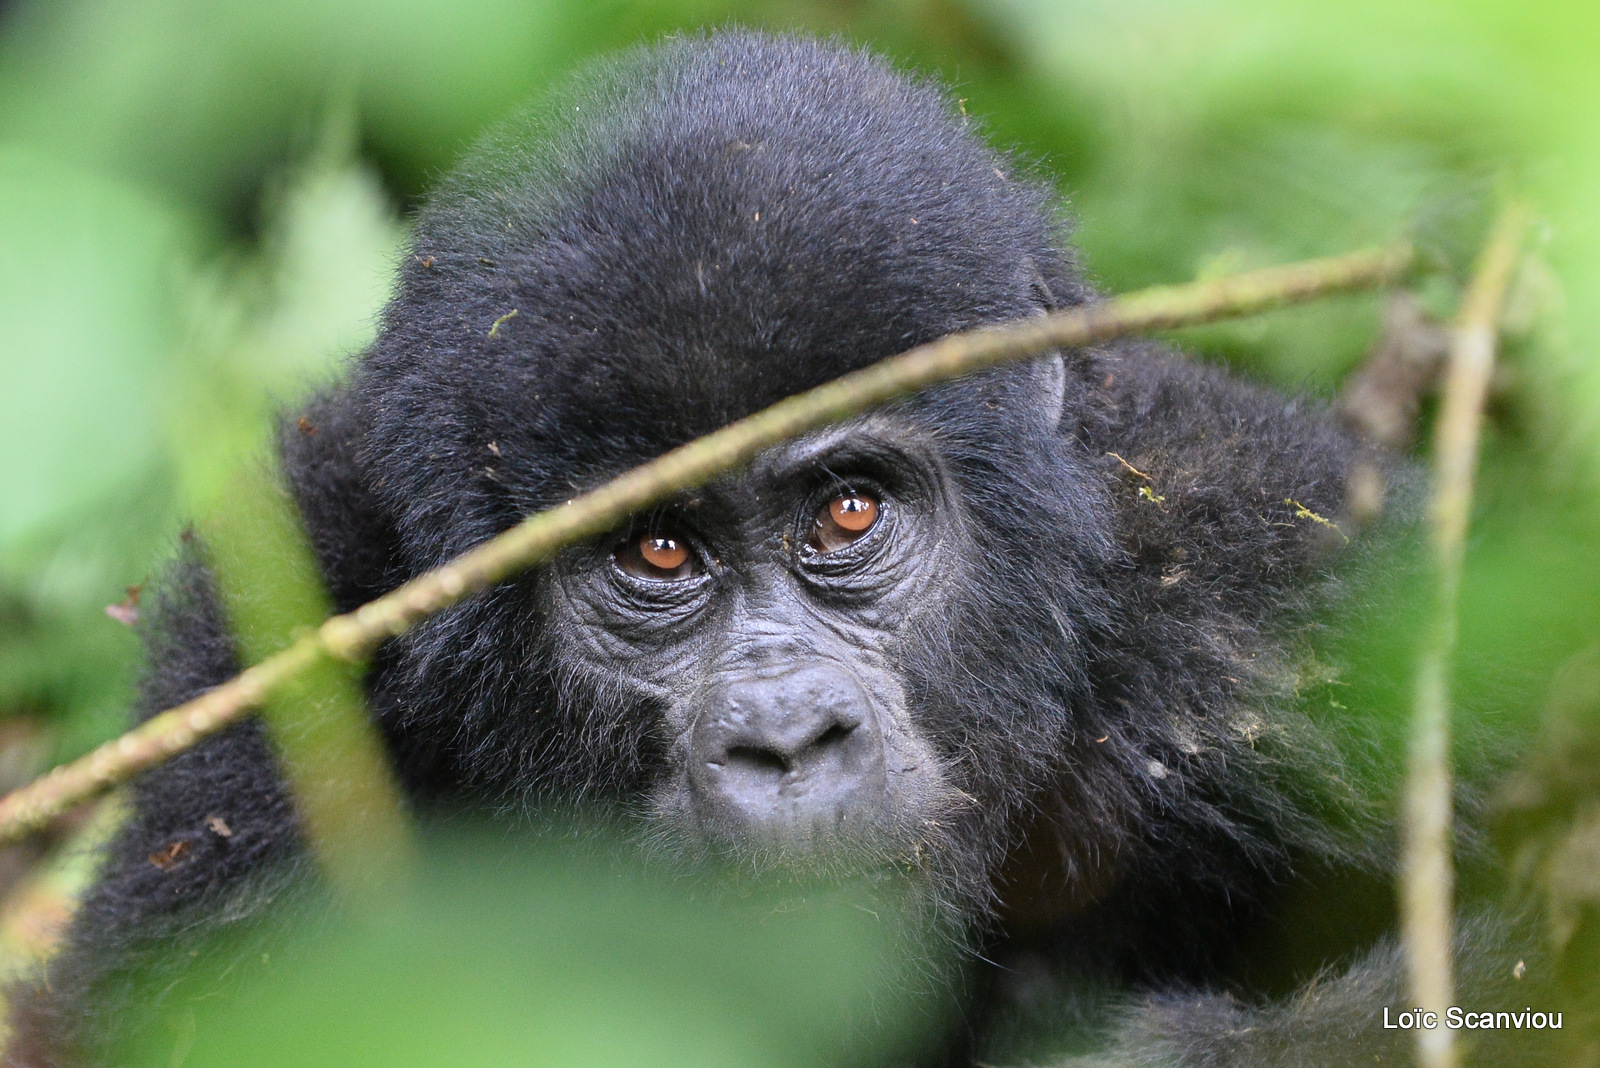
0,0,1600,1063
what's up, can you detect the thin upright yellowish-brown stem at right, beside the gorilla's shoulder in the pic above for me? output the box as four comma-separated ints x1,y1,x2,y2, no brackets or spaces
1400,205,1528,1068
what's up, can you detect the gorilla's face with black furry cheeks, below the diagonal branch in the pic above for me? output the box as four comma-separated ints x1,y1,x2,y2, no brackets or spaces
480,358,1110,921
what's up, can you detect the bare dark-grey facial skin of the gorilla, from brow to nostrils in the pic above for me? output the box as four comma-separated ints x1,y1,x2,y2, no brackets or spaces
549,417,973,852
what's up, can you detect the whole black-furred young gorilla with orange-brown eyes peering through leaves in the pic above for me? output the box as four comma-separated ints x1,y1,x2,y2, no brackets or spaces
0,34,1548,1065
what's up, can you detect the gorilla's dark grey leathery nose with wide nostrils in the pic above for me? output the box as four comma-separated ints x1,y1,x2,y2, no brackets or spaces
690,664,885,838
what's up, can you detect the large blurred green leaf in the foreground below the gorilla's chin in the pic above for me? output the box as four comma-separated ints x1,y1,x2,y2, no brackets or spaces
107,827,950,1068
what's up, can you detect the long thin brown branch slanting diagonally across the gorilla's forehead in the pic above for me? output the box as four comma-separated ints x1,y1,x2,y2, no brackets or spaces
0,245,1414,843
